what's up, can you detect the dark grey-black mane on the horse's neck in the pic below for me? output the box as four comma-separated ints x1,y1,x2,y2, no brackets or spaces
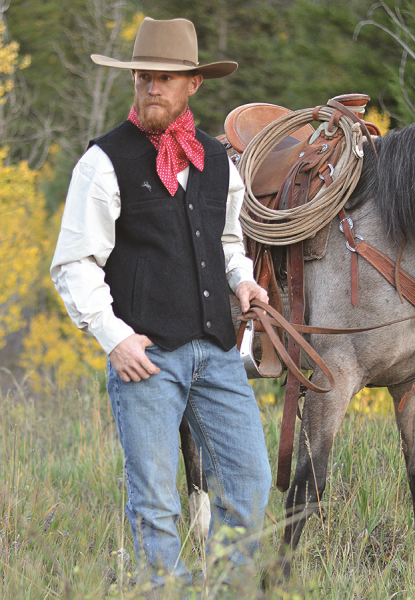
346,124,415,245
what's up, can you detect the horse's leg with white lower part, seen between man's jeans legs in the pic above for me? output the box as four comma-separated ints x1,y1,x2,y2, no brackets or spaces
179,417,210,541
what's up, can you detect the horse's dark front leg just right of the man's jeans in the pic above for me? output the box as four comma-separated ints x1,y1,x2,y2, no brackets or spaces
282,361,360,577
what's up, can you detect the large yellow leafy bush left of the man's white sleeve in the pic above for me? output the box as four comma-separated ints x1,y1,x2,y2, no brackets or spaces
0,150,105,391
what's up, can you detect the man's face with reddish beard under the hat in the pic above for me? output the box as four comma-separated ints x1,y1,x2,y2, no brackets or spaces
133,71,203,131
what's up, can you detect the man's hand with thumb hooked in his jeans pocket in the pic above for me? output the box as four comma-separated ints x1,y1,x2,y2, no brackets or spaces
109,333,160,383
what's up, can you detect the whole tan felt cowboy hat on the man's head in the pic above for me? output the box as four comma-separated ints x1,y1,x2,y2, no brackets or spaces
91,17,238,79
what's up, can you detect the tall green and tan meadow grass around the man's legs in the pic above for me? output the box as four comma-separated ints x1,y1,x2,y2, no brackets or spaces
0,382,415,600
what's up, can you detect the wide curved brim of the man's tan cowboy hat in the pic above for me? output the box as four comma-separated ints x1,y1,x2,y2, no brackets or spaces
91,54,238,79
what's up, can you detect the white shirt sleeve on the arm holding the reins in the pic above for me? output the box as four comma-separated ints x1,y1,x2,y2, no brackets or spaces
222,159,255,292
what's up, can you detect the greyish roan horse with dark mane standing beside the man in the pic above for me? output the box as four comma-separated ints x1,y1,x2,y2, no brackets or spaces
181,118,415,575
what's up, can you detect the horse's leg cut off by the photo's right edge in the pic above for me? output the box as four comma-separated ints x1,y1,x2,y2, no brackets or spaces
388,382,415,514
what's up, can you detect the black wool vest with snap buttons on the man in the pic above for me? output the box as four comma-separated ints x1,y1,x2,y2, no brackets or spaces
90,121,235,350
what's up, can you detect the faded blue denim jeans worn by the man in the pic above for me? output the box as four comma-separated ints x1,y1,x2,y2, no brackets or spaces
108,338,271,586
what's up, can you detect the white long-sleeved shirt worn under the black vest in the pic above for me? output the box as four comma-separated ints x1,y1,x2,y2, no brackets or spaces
51,145,254,354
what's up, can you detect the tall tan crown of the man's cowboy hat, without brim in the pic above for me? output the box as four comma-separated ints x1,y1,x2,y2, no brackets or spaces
133,17,198,67
